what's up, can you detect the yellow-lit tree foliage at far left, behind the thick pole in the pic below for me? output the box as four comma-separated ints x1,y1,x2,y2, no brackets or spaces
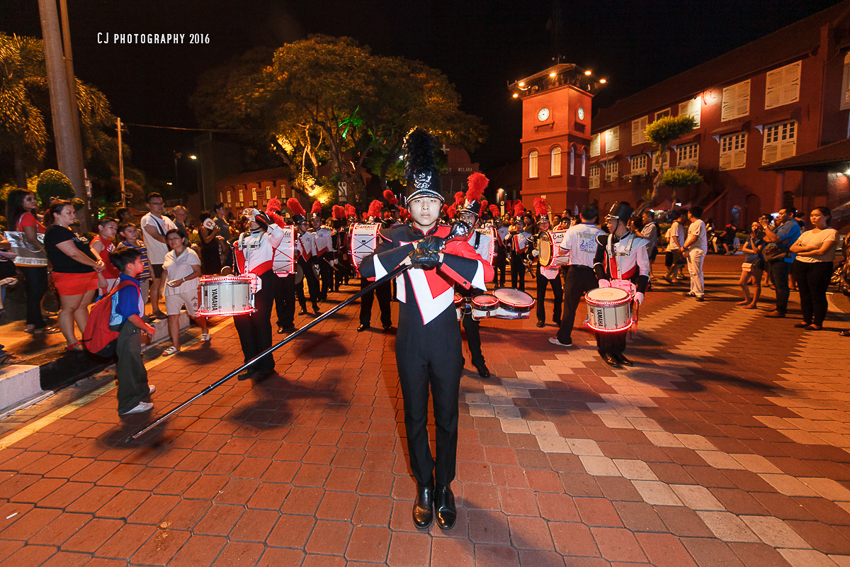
0,32,117,187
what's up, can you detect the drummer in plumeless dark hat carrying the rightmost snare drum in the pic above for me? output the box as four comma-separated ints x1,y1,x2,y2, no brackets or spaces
593,202,649,366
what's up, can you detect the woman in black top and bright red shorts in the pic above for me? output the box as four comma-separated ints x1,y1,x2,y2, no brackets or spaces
44,200,106,350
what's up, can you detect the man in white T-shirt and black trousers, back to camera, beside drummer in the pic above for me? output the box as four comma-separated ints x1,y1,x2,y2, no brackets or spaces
549,205,605,346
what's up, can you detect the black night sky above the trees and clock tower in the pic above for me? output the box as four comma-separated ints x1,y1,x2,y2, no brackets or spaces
0,0,837,183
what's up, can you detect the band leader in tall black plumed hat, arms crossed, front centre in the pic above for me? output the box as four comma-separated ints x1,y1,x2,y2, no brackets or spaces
360,129,493,529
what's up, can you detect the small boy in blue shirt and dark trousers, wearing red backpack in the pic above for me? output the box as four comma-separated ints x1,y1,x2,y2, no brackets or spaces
109,248,155,415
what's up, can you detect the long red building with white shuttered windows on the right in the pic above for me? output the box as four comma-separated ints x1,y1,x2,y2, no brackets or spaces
588,1,850,226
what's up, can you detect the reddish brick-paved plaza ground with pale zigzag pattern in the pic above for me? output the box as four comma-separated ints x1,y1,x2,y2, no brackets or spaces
0,257,850,567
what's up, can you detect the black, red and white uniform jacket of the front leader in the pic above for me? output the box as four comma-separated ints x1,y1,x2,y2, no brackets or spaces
360,224,493,325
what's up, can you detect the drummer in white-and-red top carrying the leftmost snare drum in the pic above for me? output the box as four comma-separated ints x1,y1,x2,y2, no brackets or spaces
233,209,283,380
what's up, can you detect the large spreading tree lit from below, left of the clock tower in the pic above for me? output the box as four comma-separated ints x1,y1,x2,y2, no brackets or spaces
192,36,485,200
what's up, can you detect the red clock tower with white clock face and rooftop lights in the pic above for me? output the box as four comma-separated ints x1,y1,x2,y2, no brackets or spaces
508,63,606,212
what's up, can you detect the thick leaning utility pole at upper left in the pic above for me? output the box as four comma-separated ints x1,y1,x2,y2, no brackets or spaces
38,0,88,228
